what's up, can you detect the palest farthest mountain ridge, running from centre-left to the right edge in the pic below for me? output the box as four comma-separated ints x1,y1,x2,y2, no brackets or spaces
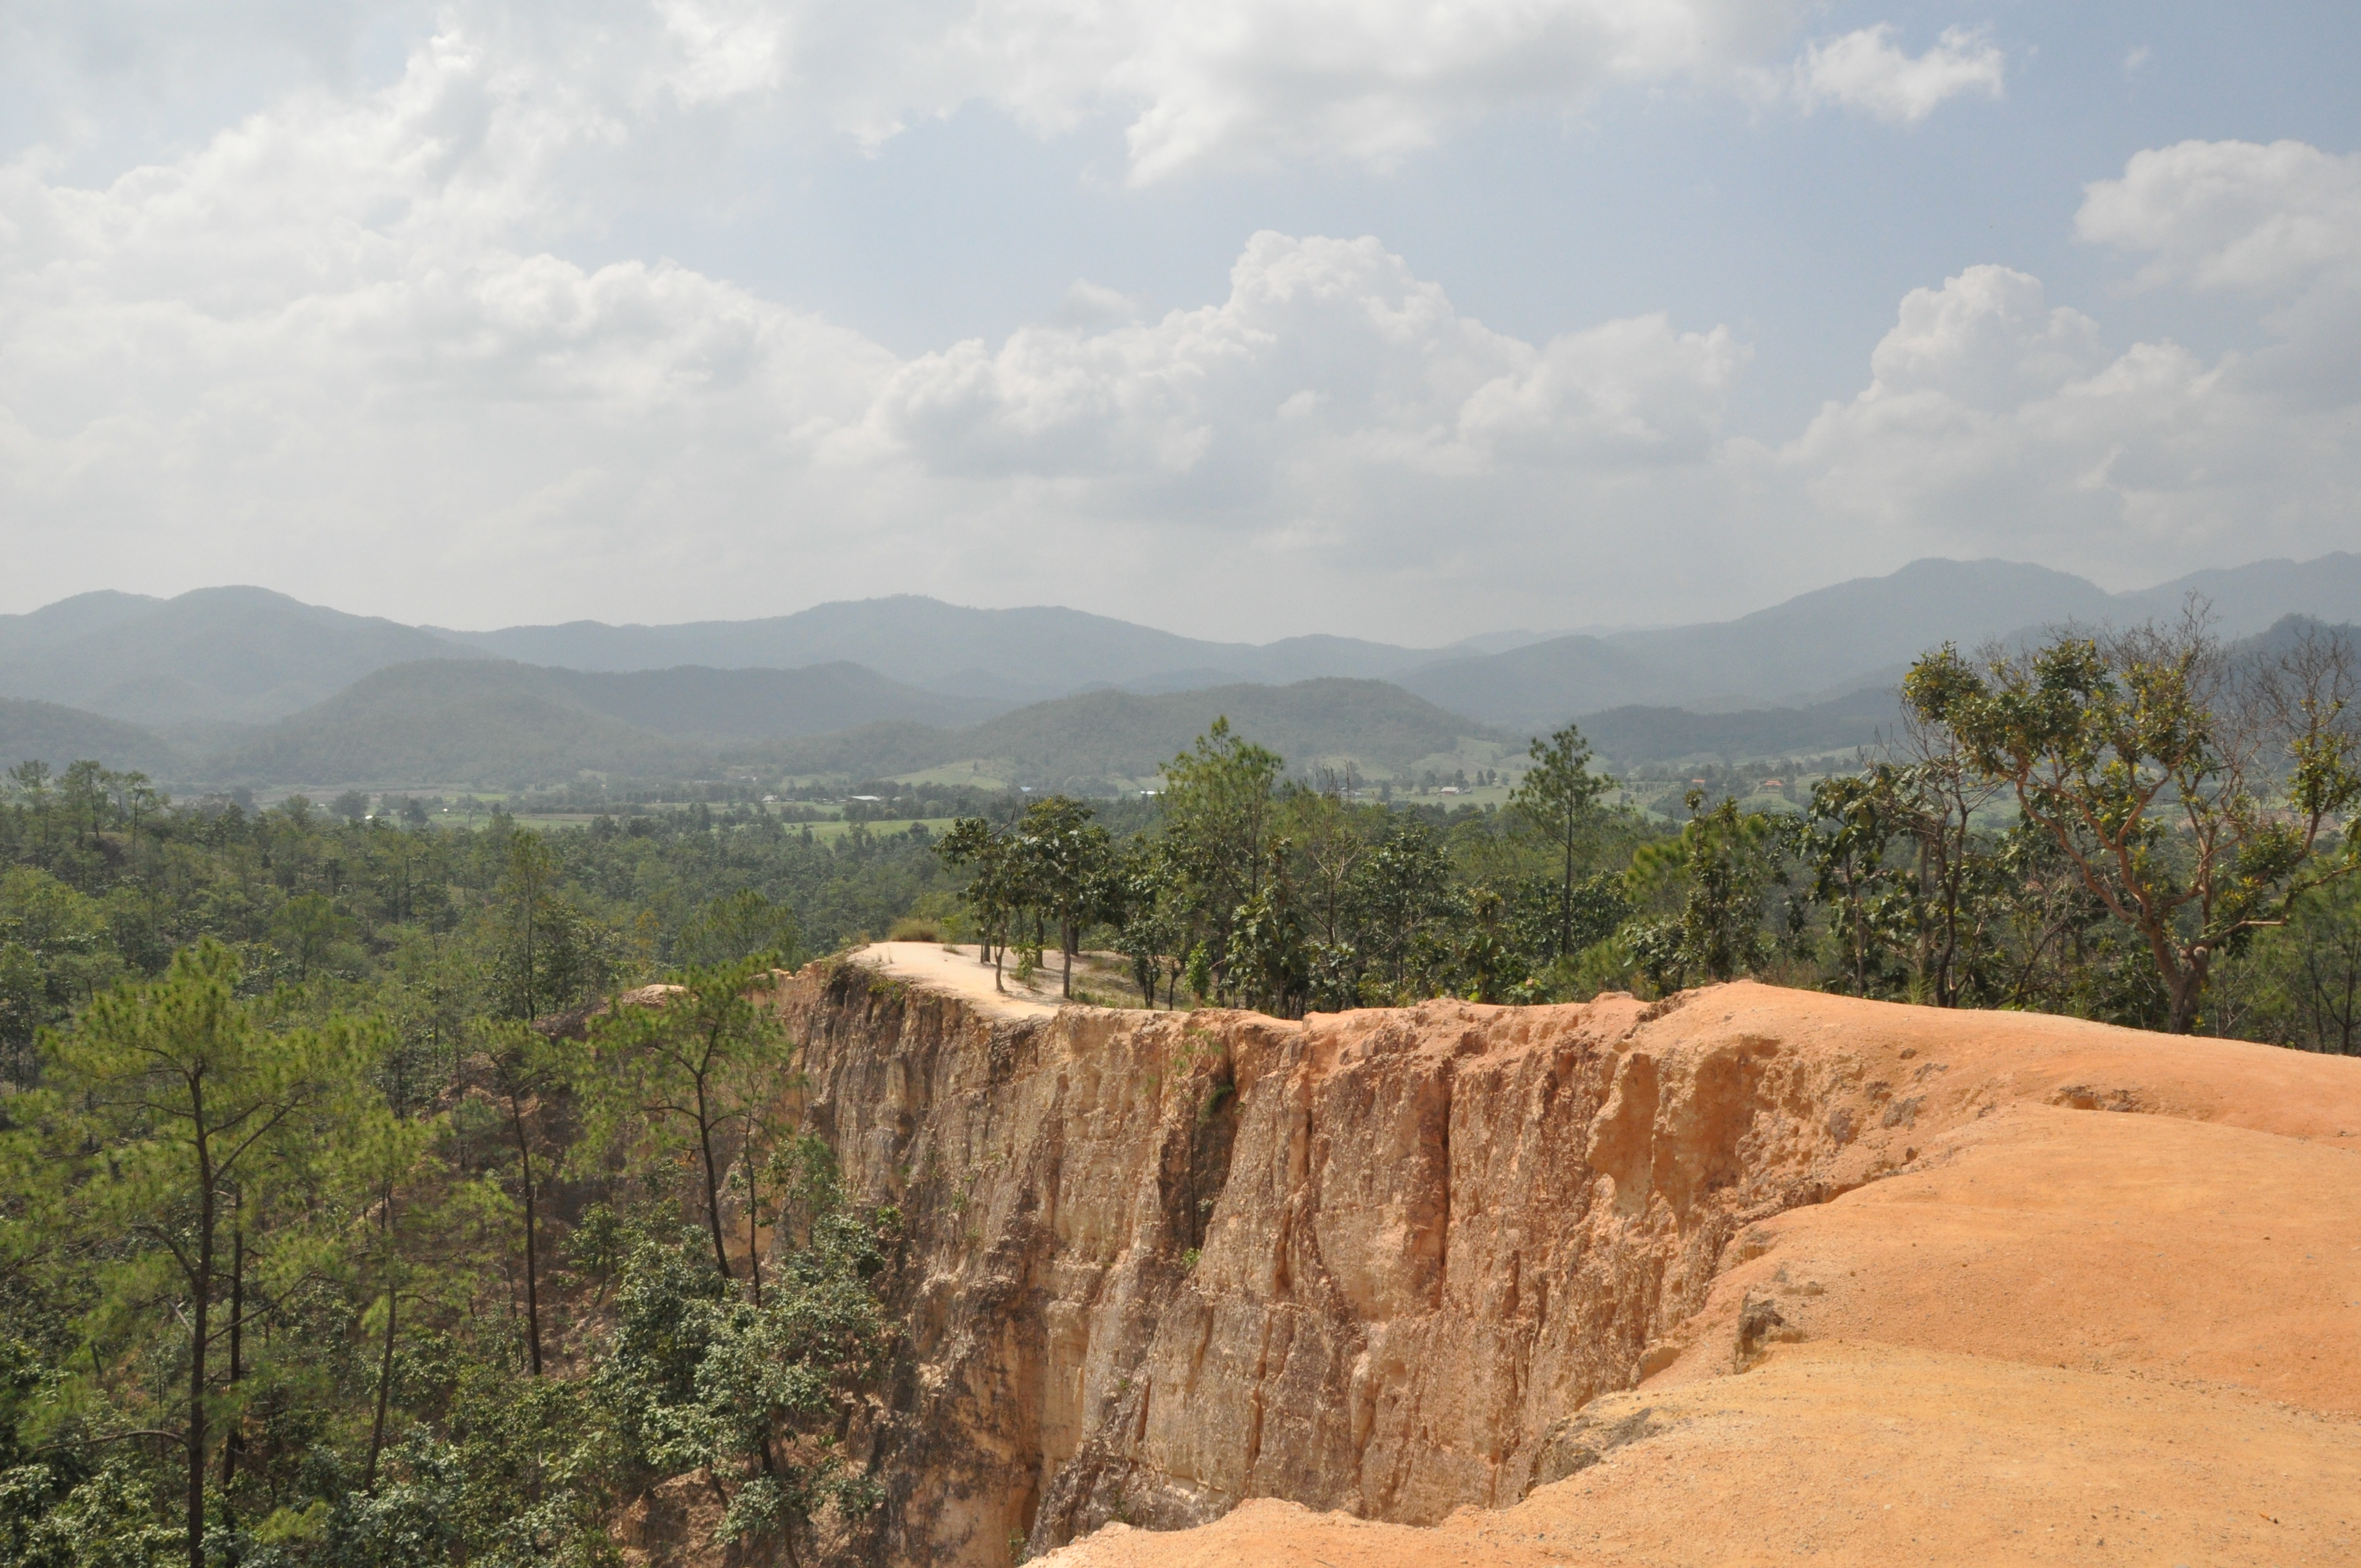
442,555,2361,727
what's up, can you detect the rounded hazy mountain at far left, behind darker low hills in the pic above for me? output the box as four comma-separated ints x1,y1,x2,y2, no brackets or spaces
0,588,479,725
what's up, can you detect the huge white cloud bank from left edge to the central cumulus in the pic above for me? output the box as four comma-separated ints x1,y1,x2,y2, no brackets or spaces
0,21,1775,635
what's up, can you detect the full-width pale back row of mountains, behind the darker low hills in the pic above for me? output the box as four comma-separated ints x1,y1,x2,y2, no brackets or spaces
0,555,2361,756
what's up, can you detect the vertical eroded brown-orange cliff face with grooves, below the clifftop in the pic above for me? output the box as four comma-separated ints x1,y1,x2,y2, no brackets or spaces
781,966,1936,1566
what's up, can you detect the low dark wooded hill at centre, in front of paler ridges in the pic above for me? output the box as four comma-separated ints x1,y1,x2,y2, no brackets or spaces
732,678,1499,786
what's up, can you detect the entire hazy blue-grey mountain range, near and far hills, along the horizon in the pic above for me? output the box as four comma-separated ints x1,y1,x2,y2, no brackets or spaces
0,553,2361,789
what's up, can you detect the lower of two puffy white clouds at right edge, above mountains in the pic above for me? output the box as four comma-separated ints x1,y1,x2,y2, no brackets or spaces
1778,254,2361,583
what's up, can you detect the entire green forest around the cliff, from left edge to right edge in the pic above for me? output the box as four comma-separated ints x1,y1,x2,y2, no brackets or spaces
0,628,2361,1568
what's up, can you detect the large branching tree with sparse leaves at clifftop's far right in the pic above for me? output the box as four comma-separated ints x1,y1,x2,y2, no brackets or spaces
1903,609,2361,1035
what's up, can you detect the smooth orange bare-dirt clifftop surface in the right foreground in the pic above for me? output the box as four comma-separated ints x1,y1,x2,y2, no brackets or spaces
1036,985,2361,1568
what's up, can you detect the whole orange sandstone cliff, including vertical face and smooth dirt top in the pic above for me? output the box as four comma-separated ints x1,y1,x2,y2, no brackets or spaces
755,945,2361,1568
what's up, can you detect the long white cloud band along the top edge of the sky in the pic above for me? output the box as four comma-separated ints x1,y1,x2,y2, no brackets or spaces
0,0,2005,184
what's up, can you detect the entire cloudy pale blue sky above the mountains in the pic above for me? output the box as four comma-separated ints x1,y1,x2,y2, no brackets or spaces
0,0,2361,645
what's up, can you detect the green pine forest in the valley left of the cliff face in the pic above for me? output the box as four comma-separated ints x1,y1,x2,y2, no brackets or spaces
0,767,906,1568
